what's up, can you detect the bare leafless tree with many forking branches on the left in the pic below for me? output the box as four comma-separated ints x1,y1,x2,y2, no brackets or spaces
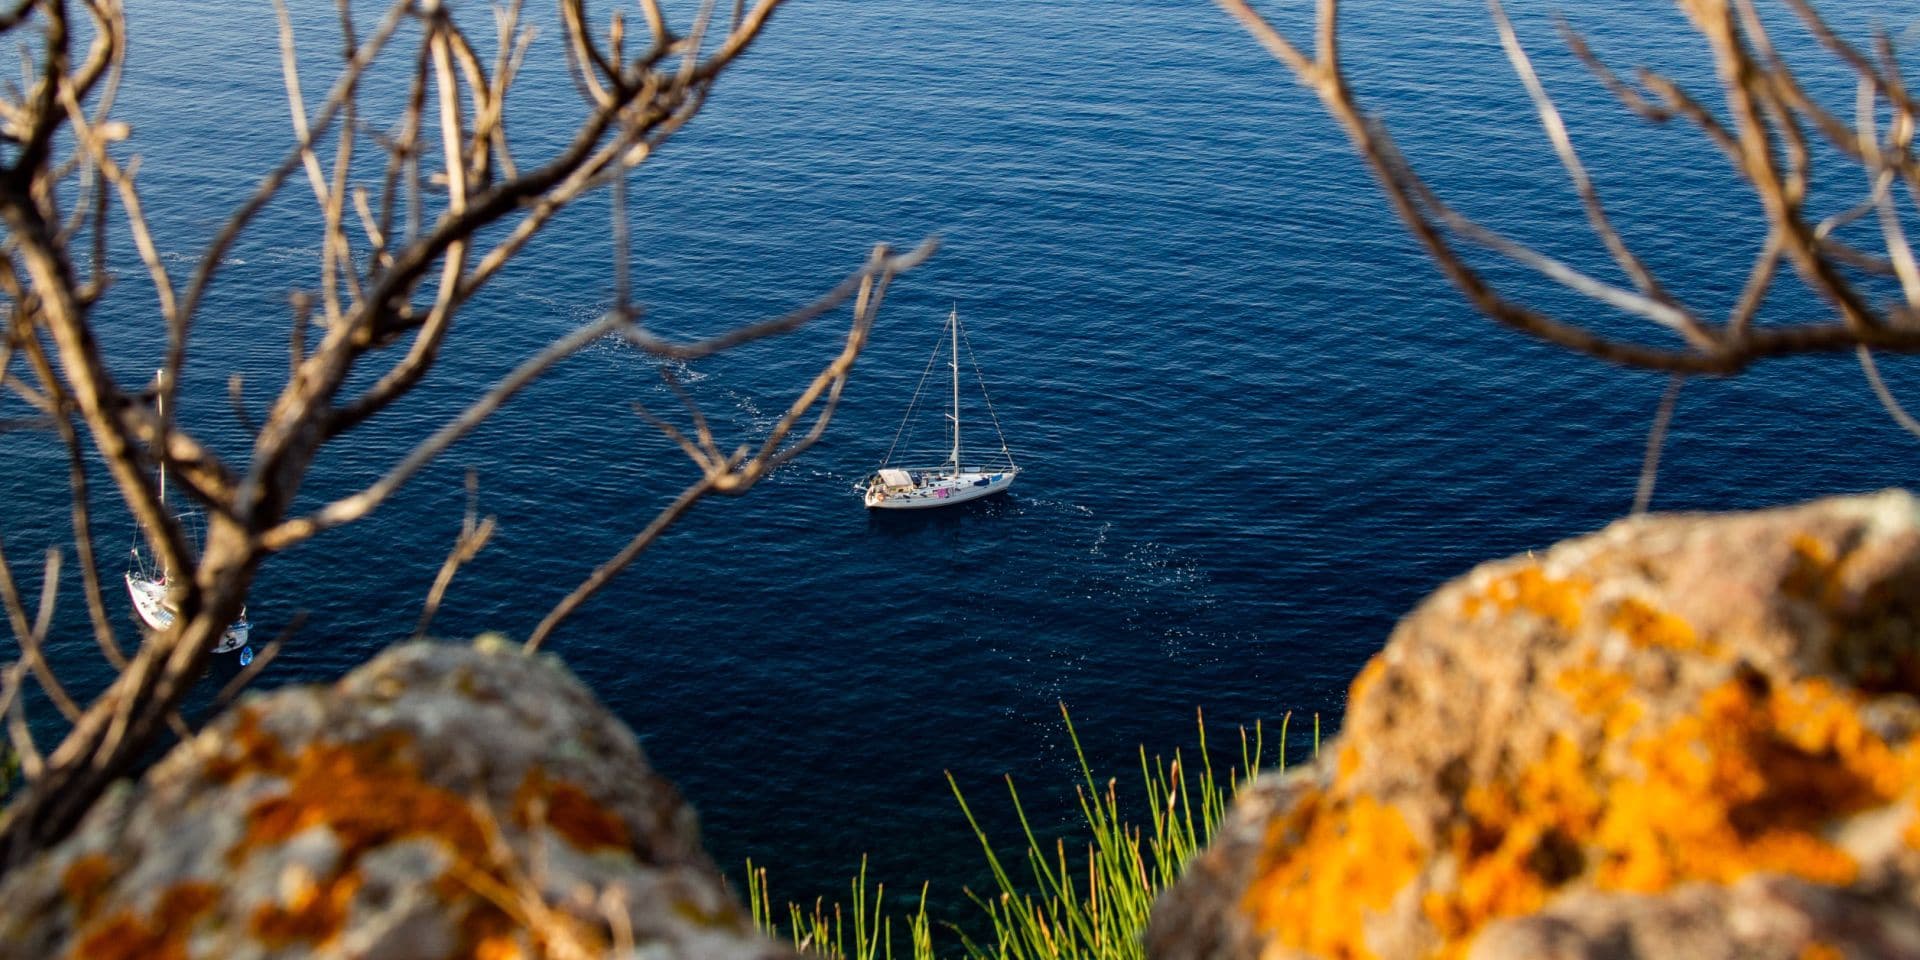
0,0,931,872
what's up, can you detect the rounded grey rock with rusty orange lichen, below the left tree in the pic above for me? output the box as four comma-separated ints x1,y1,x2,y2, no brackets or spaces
0,643,791,960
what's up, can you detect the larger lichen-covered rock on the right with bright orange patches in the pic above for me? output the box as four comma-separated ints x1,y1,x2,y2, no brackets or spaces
1148,492,1920,960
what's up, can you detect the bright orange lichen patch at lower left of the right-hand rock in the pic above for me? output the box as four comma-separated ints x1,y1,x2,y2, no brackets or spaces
1240,793,1425,960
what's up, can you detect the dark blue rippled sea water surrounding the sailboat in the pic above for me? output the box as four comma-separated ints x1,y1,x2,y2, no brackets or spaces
0,0,1920,913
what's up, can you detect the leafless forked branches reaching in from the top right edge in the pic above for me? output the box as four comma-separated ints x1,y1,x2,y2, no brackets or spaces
1217,0,1920,374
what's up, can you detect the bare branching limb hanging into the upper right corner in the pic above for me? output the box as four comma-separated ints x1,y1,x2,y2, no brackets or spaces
1217,0,1920,374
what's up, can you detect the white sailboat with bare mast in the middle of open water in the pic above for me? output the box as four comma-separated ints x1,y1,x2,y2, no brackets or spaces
864,307,1020,511
